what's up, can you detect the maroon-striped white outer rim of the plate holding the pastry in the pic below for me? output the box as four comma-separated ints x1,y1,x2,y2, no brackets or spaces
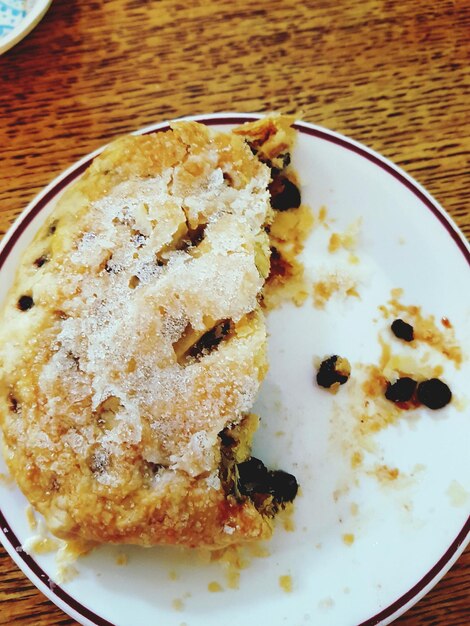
0,113,470,626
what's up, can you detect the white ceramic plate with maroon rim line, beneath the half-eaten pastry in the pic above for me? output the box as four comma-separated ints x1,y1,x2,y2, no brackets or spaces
0,114,470,626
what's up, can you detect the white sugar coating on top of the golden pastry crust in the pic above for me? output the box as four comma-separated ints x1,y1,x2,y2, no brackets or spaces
8,127,269,489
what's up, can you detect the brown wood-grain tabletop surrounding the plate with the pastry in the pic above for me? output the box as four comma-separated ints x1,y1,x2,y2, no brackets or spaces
0,0,470,626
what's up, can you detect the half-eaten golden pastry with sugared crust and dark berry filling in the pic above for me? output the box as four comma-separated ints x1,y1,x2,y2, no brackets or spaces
0,117,297,548
